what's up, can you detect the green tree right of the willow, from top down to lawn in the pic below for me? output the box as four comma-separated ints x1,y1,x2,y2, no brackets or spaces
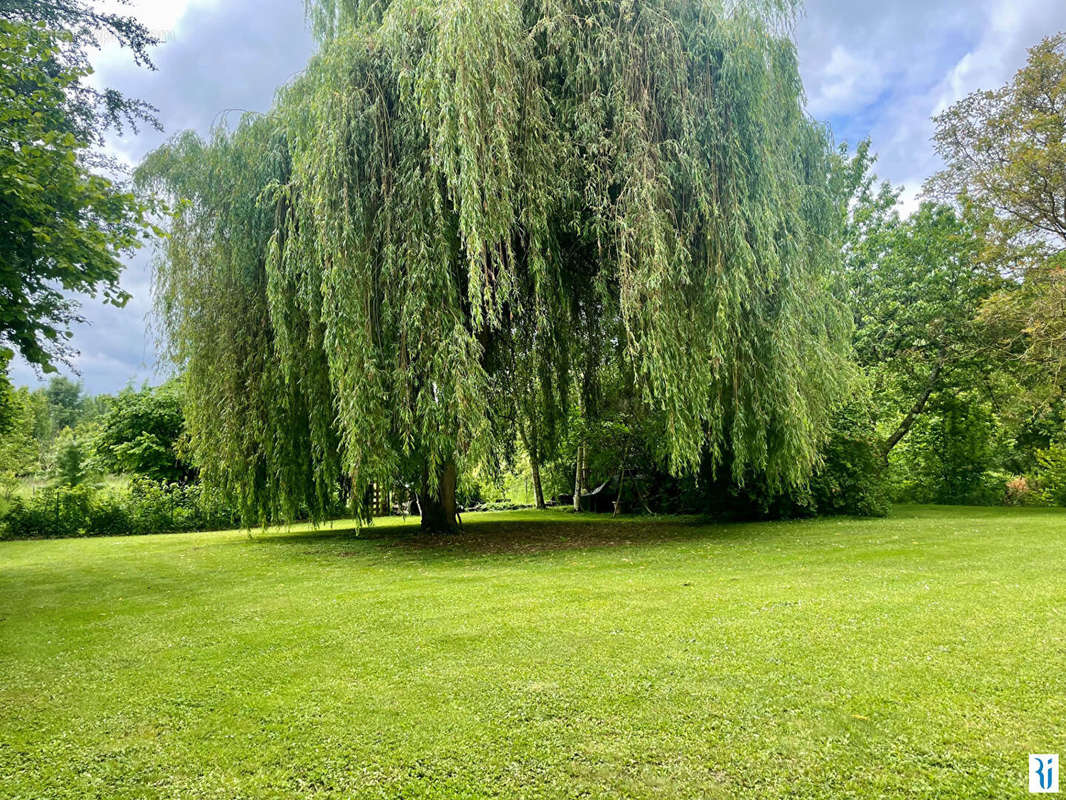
830,145,1027,502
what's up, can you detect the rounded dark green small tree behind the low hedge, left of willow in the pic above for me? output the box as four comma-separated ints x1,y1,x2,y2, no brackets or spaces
95,385,196,483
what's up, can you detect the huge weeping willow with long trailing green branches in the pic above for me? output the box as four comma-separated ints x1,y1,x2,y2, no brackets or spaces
140,0,847,529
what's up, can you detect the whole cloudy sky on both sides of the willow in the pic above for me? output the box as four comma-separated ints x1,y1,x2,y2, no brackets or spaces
11,0,1066,394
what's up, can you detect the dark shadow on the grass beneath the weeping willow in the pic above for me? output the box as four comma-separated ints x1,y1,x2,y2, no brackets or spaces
247,511,822,558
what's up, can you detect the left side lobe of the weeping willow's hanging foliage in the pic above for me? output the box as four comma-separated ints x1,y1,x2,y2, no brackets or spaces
138,118,341,523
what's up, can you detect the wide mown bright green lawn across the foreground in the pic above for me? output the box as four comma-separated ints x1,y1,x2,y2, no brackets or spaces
0,508,1066,799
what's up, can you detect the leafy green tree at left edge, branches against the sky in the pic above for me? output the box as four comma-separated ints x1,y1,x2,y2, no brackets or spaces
0,20,154,371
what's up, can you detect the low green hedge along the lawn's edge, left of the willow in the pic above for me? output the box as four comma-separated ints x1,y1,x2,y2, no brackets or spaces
0,479,239,539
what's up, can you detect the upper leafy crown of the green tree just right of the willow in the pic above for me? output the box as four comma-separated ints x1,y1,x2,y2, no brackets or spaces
840,153,1005,458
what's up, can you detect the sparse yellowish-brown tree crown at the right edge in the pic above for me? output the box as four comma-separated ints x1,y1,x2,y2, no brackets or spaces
926,33,1066,384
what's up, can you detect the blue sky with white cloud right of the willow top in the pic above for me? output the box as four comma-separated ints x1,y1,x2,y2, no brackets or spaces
796,0,1066,210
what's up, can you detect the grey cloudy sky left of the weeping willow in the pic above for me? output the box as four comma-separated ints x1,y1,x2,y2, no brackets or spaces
12,0,313,393
